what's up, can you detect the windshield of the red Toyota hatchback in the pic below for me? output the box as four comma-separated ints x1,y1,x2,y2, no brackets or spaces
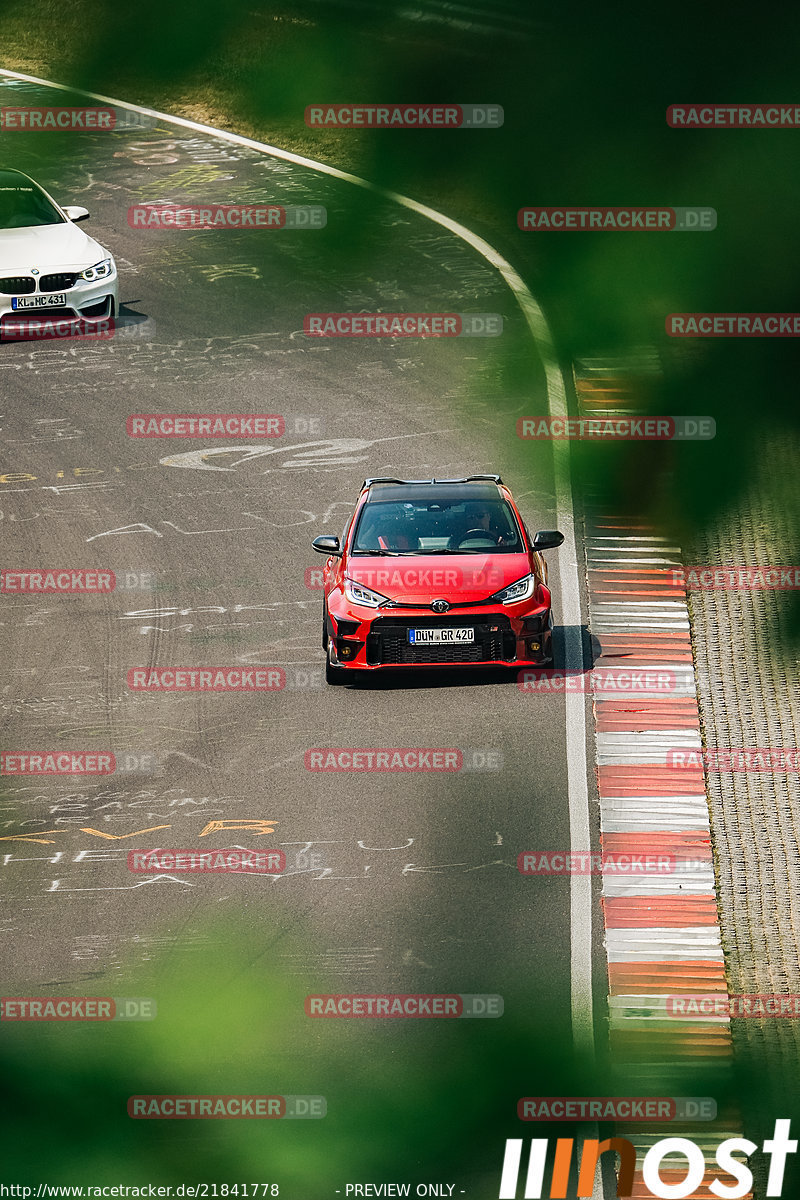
350,497,524,554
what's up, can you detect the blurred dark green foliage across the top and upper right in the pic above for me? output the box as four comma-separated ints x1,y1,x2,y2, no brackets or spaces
0,0,800,547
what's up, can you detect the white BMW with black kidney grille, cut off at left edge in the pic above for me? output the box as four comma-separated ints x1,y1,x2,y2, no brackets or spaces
0,169,118,329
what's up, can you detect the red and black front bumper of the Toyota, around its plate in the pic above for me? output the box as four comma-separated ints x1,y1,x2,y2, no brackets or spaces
327,604,553,671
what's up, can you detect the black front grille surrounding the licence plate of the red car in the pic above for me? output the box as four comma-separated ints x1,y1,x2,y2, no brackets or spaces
367,616,517,666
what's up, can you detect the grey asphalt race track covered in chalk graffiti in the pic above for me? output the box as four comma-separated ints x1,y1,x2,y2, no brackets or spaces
0,83,602,1200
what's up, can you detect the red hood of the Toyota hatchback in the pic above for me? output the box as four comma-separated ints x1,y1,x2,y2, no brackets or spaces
345,553,530,605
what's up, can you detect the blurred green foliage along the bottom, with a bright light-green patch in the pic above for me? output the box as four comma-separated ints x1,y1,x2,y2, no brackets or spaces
0,923,793,1200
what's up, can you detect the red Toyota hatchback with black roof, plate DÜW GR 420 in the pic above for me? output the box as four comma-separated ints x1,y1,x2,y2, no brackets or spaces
313,475,564,684
